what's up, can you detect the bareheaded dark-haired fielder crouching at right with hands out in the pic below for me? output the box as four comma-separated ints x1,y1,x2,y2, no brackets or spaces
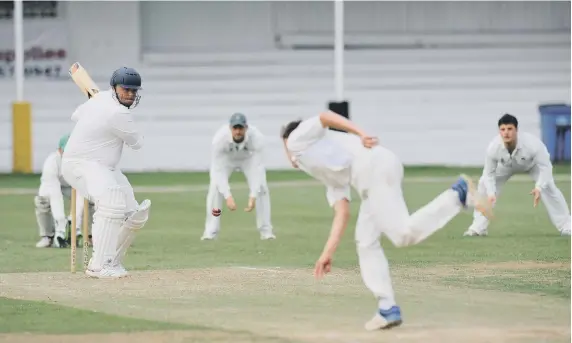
464,114,570,236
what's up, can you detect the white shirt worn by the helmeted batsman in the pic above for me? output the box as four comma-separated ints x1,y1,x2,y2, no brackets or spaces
63,90,143,169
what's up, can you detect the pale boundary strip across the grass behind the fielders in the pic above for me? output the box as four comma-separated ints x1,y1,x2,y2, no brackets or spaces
0,174,570,195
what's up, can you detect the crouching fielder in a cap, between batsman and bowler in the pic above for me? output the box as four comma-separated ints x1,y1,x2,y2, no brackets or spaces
201,113,276,240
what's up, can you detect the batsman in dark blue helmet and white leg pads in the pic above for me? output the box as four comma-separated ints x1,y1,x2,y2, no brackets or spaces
62,67,151,278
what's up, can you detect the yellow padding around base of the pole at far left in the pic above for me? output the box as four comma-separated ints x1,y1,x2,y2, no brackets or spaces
12,101,32,174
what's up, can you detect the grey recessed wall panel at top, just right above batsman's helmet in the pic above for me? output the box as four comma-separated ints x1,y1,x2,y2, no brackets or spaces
140,1,274,51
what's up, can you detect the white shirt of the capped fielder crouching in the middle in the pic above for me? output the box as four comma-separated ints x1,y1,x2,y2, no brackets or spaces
211,125,265,199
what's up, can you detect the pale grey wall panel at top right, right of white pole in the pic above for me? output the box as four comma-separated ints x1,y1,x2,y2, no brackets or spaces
346,1,570,33
